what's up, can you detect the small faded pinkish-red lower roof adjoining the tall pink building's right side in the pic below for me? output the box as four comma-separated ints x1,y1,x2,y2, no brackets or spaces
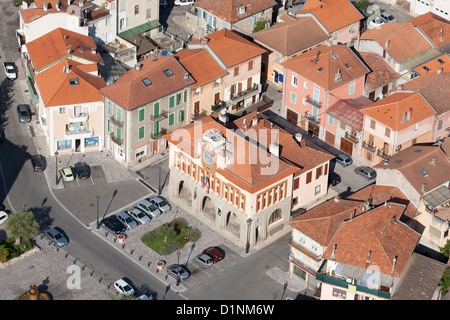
326,96,373,131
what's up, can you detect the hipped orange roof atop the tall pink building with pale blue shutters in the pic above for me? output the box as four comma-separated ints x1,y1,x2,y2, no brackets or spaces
282,45,370,90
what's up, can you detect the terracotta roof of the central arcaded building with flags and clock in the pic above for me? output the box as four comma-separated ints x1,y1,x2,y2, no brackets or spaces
164,113,333,193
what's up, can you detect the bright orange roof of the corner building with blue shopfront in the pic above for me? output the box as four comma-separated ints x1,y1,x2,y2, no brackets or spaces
36,59,105,107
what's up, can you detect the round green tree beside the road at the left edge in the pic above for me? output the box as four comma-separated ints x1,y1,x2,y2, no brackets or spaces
5,212,39,245
